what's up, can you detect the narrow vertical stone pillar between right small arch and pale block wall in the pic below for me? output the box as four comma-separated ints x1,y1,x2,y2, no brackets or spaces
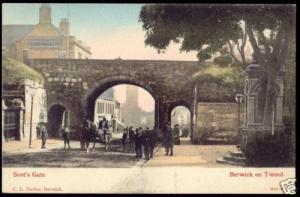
191,83,199,143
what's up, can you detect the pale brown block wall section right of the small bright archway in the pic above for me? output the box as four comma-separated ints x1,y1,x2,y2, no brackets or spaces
194,102,244,143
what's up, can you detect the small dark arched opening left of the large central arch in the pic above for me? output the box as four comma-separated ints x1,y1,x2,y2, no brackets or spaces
48,104,68,138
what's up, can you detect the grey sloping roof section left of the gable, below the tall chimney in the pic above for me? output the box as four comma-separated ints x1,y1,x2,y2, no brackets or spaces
2,25,35,44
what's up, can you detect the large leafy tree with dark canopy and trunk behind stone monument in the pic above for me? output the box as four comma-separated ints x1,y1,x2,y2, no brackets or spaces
140,4,295,128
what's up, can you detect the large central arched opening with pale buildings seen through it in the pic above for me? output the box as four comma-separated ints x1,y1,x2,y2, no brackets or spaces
86,81,155,133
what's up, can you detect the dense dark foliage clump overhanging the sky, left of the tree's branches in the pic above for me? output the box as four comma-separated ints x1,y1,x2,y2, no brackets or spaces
140,5,243,60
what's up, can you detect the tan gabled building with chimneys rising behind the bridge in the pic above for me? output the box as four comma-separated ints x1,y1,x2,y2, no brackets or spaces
2,4,91,62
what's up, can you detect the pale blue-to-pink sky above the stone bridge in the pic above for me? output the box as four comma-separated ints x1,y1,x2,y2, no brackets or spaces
2,3,197,61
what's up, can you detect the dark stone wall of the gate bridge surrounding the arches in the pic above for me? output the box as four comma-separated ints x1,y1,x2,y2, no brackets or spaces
29,59,234,140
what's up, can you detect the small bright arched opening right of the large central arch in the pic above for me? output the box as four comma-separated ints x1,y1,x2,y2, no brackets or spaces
171,105,191,140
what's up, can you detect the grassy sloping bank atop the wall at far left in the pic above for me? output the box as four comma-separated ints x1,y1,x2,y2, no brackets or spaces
2,57,45,84
